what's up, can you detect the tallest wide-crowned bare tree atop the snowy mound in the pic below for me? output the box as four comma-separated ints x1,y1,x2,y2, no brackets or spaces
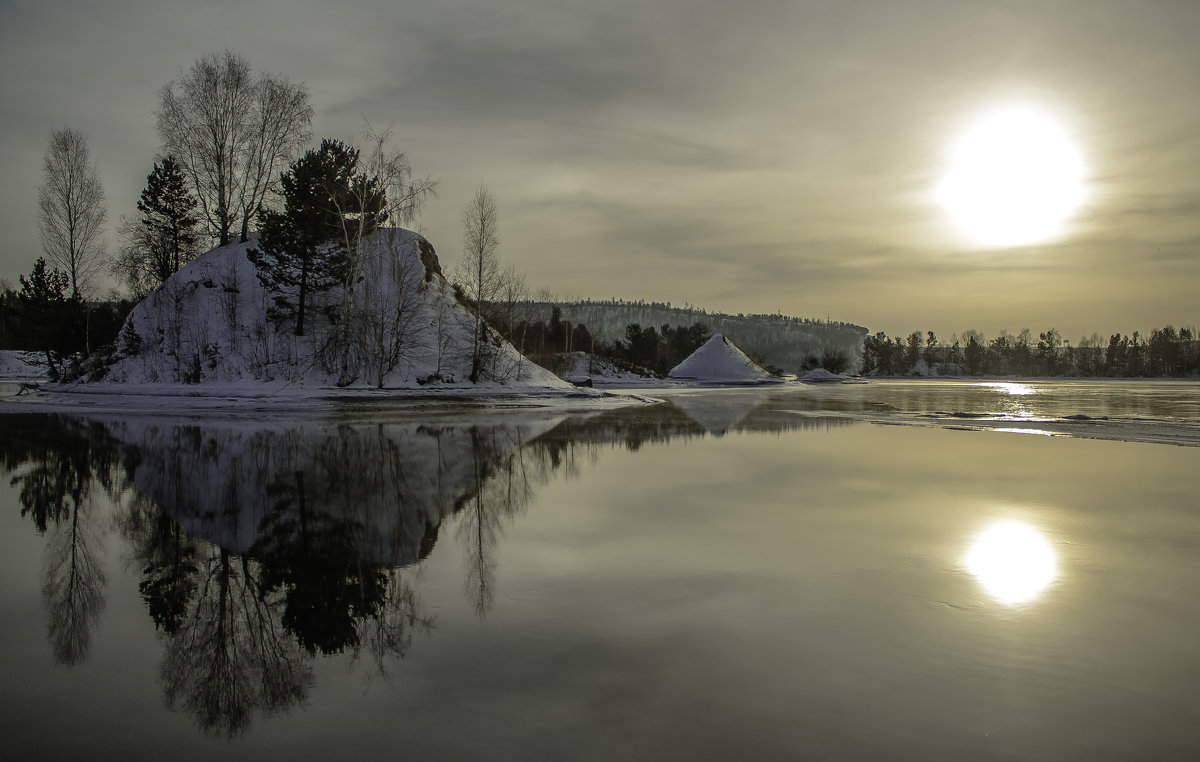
156,50,312,246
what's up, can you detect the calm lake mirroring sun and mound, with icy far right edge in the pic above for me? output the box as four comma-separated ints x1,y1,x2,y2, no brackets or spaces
0,382,1200,760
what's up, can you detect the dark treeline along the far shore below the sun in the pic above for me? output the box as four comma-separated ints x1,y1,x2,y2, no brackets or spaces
860,325,1200,378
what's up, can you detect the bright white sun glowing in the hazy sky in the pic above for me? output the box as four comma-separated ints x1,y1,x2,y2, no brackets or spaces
937,107,1084,247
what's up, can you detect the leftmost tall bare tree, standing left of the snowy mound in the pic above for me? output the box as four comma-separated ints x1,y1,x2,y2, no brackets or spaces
37,128,108,299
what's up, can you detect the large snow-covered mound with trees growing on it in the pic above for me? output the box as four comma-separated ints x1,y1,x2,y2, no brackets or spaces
93,228,571,390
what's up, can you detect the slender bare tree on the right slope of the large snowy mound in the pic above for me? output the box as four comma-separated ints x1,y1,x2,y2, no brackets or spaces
455,186,500,383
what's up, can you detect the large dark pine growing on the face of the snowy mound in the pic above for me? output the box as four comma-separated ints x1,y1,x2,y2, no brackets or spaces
250,139,388,336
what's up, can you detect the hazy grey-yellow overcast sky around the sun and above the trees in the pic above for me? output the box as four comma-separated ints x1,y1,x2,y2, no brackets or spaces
0,0,1200,341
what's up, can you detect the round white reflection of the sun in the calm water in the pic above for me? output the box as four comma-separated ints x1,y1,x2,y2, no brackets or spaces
962,521,1058,606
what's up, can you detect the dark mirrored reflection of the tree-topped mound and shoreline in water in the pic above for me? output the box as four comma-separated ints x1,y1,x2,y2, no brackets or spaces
0,395,850,738
